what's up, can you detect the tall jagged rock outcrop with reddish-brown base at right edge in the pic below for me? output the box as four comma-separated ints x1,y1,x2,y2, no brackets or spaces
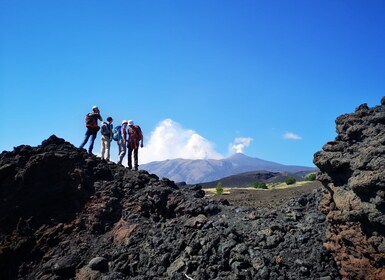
314,97,385,279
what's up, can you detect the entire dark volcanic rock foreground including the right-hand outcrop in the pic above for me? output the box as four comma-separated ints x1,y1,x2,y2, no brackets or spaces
0,96,385,280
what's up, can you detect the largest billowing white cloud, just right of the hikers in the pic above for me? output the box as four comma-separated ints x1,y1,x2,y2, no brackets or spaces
139,119,223,164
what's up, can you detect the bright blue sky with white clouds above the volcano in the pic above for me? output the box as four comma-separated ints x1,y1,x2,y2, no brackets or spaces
0,0,385,166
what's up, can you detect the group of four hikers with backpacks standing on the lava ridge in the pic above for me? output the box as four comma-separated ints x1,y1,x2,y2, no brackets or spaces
79,106,143,170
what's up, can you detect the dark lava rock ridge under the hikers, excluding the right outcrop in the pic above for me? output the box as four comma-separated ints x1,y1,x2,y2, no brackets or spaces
0,136,340,280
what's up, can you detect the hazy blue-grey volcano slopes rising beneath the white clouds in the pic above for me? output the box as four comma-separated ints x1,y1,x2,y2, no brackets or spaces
140,153,316,184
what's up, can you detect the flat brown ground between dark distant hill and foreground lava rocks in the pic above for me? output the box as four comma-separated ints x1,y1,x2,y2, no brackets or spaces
207,181,322,208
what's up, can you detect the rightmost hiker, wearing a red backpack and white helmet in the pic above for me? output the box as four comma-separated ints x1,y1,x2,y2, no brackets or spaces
127,120,143,170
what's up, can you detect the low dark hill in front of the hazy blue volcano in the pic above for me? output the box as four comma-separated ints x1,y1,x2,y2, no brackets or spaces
201,171,309,188
